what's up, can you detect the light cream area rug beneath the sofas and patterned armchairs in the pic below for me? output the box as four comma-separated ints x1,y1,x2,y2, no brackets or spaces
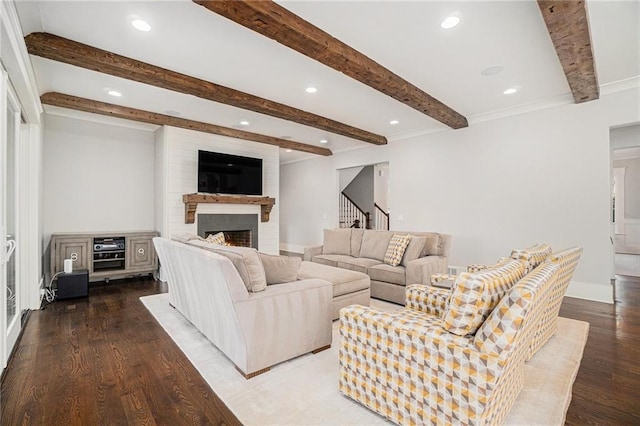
140,294,589,426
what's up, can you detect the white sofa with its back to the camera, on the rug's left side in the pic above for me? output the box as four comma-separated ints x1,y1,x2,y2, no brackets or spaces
153,237,333,378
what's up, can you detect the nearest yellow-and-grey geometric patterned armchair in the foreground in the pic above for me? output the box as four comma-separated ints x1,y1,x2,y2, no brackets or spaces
339,261,561,425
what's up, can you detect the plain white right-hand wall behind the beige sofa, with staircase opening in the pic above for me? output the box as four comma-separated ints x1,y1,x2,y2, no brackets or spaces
281,88,640,302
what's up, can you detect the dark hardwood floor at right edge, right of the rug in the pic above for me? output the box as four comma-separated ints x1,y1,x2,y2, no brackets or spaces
560,275,640,425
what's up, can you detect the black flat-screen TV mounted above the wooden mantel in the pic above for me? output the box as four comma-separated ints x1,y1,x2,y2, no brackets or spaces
198,150,262,195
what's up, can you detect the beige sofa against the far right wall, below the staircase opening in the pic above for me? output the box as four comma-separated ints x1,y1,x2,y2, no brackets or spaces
304,228,451,305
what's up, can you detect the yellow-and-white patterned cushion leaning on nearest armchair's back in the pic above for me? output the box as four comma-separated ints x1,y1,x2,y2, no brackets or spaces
442,259,525,336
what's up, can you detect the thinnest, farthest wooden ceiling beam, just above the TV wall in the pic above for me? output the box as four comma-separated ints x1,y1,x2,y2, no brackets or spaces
40,92,333,156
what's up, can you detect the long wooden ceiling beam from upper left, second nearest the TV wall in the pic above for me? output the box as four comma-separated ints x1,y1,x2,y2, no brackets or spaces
25,33,387,145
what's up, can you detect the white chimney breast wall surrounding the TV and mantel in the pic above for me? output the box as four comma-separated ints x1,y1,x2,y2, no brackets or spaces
155,127,280,254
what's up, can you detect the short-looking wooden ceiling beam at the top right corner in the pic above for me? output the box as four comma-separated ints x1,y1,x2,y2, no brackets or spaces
538,0,600,104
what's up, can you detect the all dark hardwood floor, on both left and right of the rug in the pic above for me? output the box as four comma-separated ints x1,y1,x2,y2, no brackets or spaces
0,277,640,425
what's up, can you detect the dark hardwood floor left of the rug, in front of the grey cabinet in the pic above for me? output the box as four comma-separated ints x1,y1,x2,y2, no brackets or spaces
0,279,240,425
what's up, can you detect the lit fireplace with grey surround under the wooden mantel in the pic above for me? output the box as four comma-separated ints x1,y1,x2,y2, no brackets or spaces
198,214,258,249
